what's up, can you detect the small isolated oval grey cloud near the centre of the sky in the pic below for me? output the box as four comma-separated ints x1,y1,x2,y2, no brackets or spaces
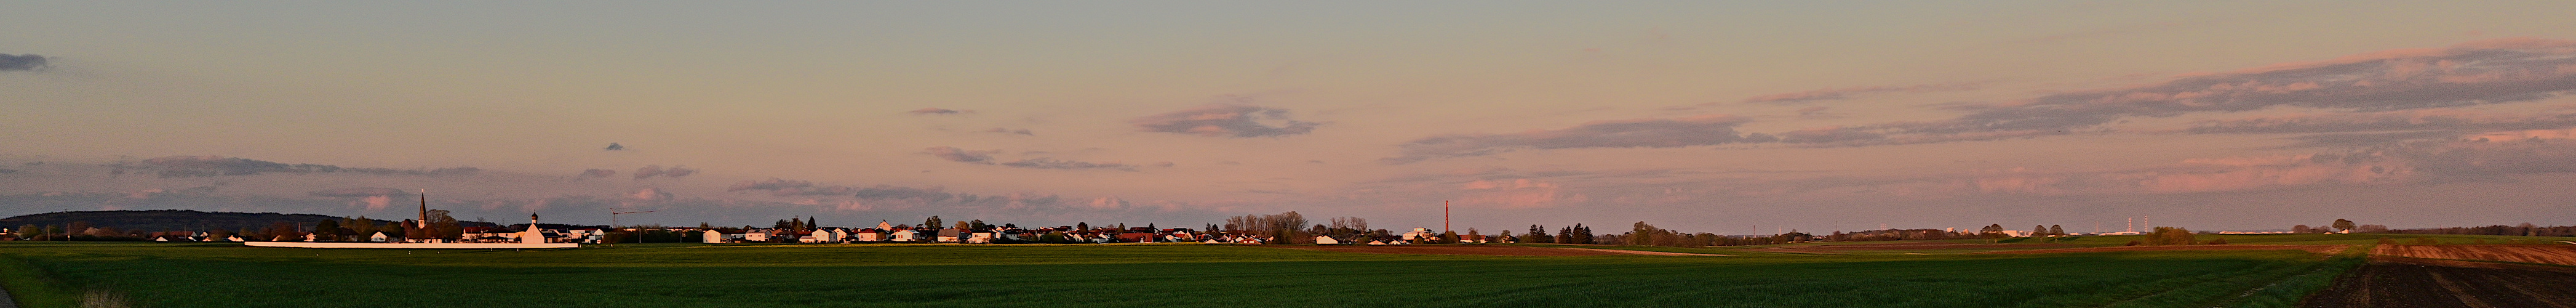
1128,103,1319,137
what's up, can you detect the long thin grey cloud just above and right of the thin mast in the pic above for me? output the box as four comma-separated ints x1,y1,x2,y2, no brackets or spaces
1381,114,1777,163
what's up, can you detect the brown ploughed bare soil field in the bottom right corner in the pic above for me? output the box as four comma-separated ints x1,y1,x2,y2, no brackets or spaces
2300,259,2576,308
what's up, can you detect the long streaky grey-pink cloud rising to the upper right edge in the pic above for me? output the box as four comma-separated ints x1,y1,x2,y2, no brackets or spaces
1891,39,2576,134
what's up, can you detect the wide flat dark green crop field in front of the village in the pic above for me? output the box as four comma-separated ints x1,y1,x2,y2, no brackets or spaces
0,241,2357,308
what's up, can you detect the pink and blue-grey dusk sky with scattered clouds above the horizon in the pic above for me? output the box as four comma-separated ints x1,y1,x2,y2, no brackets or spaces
0,0,2576,235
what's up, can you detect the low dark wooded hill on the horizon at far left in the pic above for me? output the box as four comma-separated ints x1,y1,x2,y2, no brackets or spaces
0,209,492,230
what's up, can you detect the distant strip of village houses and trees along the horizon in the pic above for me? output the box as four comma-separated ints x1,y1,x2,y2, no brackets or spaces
15,205,2576,248
